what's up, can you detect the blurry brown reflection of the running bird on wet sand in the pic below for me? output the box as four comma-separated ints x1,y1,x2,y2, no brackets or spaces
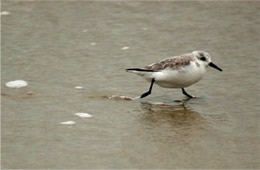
139,102,206,143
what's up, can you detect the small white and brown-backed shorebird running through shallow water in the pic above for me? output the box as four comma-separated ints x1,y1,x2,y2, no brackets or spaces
126,51,222,98
